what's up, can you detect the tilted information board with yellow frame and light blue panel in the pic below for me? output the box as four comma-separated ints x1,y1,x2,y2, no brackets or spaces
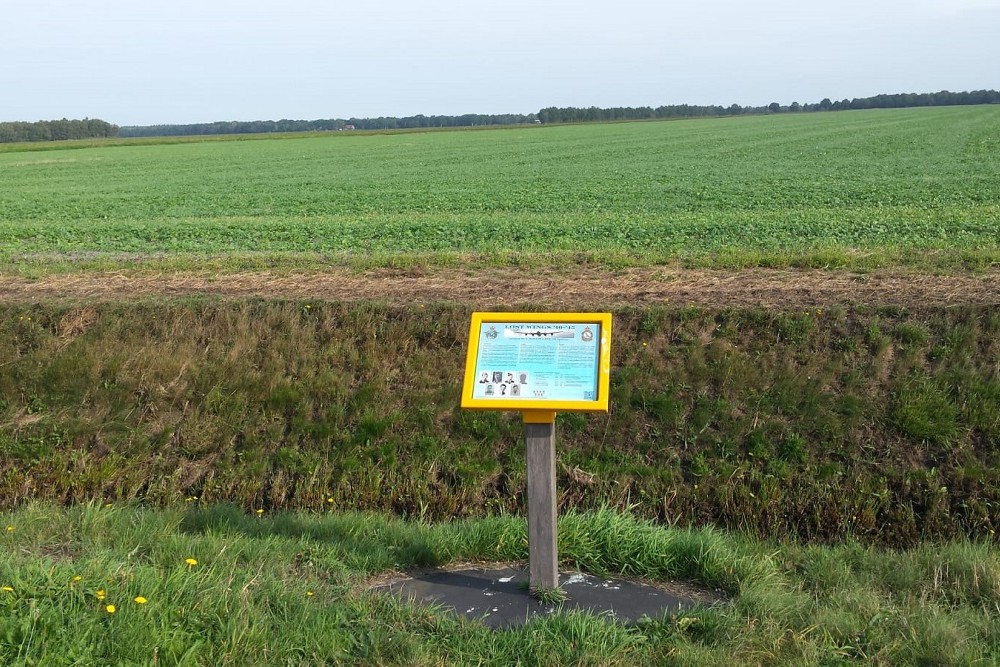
462,313,611,412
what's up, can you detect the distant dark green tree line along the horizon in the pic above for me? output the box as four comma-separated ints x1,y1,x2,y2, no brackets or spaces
0,90,1000,143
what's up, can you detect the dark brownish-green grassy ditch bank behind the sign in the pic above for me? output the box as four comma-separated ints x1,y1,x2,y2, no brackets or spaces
0,299,1000,547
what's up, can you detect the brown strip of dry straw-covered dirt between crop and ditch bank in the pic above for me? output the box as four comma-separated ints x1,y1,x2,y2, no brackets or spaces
0,268,1000,309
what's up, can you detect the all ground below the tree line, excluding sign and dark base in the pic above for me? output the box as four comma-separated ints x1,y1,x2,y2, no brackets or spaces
0,106,1000,667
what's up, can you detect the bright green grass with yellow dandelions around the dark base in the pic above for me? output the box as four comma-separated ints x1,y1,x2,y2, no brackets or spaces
0,503,1000,665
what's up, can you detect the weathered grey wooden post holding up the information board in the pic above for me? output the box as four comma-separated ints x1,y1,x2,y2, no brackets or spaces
524,420,559,592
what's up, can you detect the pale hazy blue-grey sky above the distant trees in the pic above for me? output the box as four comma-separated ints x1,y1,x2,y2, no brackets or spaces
0,0,1000,125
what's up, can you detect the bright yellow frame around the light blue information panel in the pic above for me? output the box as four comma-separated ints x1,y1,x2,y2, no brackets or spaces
462,312,611,423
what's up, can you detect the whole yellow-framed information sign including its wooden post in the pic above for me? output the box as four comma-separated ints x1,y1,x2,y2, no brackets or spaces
462,312,611,592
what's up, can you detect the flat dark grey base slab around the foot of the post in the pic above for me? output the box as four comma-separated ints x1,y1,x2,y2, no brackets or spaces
374,567,722,628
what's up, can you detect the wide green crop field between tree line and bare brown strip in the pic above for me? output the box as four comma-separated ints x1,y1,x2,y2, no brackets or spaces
0,106,1000,270
